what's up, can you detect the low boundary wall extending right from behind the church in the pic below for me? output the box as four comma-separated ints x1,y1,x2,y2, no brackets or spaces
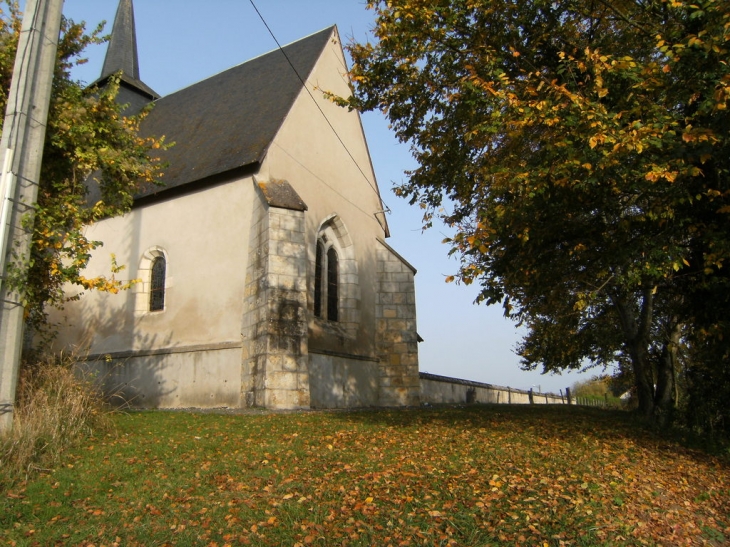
419,372,570,405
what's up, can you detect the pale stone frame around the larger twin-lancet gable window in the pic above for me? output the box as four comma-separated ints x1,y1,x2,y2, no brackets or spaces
310,213,361,337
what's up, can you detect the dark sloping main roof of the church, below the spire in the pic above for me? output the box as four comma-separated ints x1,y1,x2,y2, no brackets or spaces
137,27,335,198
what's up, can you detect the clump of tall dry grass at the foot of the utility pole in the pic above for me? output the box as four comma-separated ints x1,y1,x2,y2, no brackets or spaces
0,354,111,485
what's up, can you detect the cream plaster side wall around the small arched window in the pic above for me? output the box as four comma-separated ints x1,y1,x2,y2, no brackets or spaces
52,178,254,354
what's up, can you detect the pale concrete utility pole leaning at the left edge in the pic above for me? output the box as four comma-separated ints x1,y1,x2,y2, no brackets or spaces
0,0,63,433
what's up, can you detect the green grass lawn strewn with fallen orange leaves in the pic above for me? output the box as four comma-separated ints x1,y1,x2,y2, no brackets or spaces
0,405,730,547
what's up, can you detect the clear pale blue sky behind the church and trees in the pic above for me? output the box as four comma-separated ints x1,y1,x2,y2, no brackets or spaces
31,0,599,392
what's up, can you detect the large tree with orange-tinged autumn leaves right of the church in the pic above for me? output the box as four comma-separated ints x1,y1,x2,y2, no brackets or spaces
342,0,730,422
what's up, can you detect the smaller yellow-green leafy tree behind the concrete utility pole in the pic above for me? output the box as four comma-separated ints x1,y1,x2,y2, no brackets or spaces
0,2,162,334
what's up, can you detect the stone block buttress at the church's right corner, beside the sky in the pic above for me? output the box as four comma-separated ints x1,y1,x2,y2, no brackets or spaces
375,239,419,406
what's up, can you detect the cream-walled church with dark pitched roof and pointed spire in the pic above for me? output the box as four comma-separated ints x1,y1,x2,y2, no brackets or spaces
55,0,419,409
